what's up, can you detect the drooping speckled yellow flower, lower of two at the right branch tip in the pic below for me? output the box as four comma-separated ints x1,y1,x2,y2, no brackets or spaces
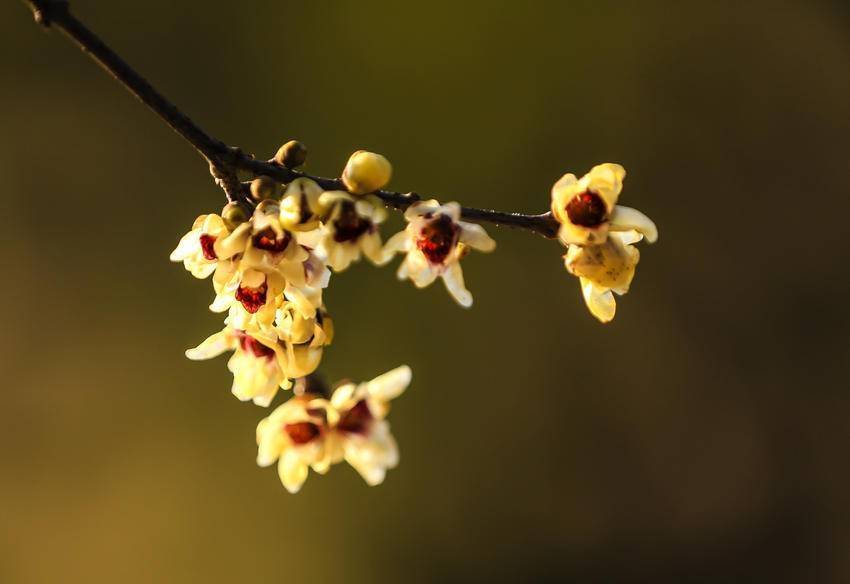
564,231,641,322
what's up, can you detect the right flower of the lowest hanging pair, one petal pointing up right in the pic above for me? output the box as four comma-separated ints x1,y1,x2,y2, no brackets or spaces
328,365,412,486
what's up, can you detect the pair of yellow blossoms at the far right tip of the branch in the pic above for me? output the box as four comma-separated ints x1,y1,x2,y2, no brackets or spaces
552,163,658,322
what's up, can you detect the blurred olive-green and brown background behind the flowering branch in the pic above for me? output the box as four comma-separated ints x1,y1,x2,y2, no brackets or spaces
0,0,850,583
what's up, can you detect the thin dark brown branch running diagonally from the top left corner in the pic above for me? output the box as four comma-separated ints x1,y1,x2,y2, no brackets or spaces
19,0,558,239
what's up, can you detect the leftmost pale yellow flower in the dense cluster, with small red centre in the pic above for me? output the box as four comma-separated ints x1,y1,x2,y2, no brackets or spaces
169,214,248,279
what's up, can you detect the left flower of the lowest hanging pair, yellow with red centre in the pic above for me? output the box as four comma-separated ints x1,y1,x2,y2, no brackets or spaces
257,396,331,493
